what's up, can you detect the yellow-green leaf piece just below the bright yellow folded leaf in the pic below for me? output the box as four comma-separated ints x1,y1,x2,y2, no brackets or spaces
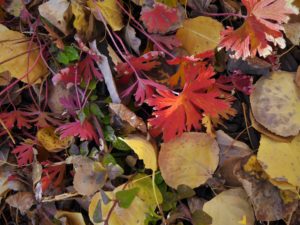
126,174,163,208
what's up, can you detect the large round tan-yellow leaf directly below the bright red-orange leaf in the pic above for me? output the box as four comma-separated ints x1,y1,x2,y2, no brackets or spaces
158,132,219,189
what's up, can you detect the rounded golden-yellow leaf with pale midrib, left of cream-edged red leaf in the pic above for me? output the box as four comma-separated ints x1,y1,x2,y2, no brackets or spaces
176,16,223,55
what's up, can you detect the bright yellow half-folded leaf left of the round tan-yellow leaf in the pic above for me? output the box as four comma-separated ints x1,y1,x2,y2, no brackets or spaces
123,135,157,171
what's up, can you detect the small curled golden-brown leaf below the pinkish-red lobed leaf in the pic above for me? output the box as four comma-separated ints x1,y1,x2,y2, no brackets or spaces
36,127,73,152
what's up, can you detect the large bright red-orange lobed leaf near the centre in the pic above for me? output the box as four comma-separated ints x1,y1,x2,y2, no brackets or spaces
146,65,230,142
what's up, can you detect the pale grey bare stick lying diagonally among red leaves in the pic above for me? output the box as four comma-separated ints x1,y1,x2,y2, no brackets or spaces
89,40,121,103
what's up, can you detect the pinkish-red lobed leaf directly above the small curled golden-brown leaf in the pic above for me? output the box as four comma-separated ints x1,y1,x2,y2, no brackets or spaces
56,119,99,143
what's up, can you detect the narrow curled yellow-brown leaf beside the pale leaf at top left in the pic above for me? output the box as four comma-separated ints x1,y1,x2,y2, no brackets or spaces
71,1,89,33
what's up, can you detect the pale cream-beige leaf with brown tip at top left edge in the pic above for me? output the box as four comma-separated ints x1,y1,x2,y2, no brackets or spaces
39,0,70,35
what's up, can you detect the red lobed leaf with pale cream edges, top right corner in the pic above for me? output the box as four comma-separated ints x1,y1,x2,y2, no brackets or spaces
219,0,298,59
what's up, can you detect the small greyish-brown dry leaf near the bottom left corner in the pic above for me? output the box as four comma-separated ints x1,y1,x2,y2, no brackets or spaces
5,192,35,214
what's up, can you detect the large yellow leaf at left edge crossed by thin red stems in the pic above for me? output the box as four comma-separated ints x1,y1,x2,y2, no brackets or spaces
0,24,48,84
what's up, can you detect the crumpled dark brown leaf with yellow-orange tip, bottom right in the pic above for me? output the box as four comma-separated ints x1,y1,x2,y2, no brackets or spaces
235,156,298,221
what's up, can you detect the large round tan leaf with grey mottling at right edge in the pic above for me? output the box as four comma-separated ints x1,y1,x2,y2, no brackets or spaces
250,71,300,137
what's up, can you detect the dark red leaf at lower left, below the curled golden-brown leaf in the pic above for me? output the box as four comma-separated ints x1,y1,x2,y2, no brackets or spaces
41,161,66,191
